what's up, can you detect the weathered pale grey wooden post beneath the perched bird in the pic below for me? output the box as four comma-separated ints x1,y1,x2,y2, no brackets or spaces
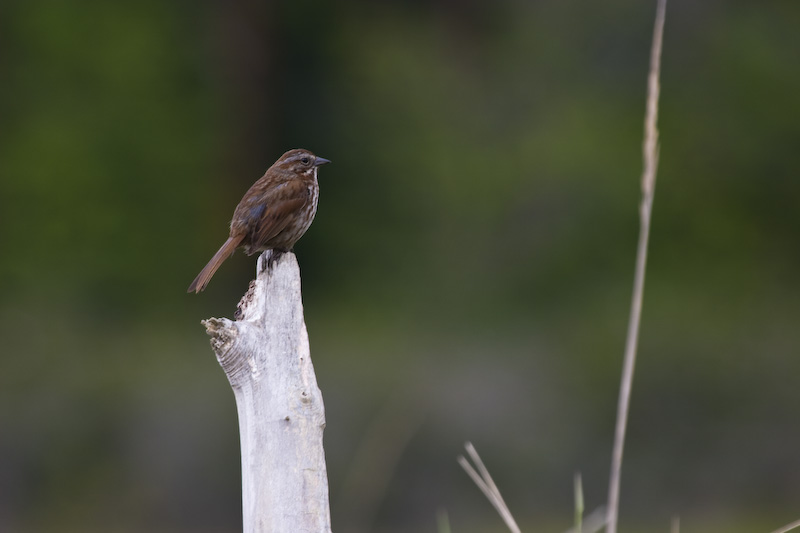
203,251,331,533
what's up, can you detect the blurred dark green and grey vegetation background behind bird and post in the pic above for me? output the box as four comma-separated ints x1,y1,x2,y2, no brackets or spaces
0,0,800,533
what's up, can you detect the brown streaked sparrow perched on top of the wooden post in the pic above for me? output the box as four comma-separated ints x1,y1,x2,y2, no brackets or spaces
187,150,330,292
